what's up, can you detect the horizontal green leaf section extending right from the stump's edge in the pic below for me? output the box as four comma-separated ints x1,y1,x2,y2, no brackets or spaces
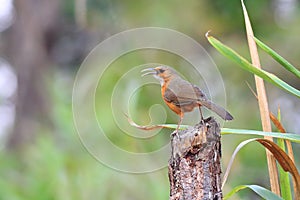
221,128,300,143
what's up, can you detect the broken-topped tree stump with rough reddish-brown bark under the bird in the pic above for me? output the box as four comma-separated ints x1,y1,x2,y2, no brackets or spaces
168,117,222,200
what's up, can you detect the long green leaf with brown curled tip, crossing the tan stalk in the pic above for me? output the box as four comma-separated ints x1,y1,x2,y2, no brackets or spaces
206,35,300,98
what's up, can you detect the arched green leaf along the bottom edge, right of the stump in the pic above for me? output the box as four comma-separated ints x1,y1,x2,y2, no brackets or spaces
224,185,283,200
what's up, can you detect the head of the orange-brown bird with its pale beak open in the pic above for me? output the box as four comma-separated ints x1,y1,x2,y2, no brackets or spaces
142,66,178,84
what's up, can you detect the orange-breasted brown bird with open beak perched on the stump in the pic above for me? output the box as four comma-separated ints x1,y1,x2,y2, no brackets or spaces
141,66,233,132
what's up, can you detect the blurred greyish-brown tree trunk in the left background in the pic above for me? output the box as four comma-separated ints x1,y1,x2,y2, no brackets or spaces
7,0,59,149
